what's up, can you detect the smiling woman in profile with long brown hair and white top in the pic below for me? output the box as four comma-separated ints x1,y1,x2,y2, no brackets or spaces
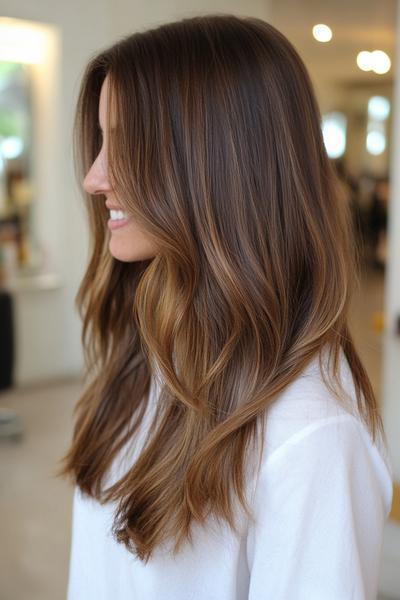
60,14,392,600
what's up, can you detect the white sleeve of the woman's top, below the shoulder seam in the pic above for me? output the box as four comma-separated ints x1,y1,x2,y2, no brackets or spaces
247,414,392,600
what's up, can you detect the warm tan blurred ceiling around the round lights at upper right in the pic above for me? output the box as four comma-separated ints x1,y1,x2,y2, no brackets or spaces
269,0,397,87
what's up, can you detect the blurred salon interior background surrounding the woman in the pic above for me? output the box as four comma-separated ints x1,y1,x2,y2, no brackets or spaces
0,0,400,600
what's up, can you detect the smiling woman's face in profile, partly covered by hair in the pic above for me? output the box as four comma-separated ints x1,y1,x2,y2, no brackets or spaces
83,76,156,262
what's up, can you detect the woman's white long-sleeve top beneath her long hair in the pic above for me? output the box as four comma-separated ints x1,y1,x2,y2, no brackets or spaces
67,354,393,600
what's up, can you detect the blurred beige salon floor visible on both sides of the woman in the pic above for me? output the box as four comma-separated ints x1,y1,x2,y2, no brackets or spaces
0,264,396,600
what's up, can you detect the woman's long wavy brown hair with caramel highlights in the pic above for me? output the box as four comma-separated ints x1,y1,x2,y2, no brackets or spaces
55,14,384,560
